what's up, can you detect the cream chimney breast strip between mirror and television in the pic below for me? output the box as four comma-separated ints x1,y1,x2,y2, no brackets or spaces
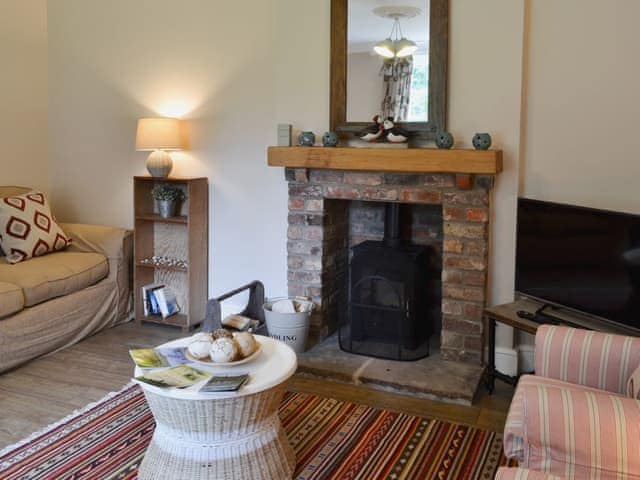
448,0,525,366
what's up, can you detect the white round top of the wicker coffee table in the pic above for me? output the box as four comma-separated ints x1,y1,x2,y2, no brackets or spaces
134,335,298,400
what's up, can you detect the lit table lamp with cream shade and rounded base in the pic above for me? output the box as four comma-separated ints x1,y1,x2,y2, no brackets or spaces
136,118,187,178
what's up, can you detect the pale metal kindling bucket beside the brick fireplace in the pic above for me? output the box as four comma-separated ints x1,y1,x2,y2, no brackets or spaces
263,297,314,353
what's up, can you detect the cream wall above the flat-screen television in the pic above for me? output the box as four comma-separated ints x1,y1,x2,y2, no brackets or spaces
522,0,640,213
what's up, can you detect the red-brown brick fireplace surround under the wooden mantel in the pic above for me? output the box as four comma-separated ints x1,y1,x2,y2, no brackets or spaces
285,168,494,363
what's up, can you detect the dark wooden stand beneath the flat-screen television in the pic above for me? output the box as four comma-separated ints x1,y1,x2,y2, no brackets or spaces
484,298,638,394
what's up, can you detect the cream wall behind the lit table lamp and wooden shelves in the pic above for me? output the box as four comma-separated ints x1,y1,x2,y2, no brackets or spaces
49,0,284,295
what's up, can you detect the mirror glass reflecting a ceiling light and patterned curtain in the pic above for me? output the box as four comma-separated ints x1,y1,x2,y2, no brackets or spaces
347,0,429,122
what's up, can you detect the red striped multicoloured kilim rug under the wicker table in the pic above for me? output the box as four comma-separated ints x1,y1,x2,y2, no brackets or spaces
0,385,506,480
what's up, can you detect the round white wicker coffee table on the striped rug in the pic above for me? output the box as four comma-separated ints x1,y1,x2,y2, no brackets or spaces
135,335,297,480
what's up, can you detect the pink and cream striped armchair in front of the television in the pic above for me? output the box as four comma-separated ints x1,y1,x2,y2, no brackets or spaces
496,325,640,480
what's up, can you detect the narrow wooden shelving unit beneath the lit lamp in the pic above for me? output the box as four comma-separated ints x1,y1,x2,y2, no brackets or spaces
133,177,209,331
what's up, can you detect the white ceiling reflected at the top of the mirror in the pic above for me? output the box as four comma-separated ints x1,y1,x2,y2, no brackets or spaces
347,0,429,53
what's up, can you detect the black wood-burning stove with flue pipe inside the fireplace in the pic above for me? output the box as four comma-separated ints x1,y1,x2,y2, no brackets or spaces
339,203,434,360
